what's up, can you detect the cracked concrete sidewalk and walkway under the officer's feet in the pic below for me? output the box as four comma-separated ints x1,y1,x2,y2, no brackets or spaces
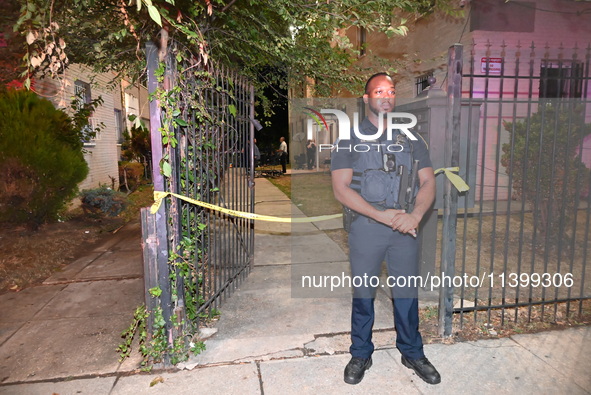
0,179,591,395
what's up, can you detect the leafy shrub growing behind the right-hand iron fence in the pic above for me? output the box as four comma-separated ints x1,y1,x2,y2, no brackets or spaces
501,100,591,235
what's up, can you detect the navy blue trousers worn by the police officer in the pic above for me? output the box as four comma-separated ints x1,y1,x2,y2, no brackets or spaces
349,216,425,359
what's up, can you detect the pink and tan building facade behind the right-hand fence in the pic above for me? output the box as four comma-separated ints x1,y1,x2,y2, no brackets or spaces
345,0,591,200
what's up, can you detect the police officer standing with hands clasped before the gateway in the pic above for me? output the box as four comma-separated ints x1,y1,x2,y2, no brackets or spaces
331,73,441,384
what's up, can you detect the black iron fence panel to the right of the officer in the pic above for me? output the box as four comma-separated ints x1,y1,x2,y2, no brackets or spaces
453,43,591,330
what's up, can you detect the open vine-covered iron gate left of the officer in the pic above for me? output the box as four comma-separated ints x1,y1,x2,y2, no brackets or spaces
143,41,254,362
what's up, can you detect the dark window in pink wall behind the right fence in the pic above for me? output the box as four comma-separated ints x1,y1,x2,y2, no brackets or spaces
540,60,583,98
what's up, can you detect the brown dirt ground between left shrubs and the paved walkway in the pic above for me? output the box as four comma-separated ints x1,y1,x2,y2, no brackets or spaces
0,187,153,294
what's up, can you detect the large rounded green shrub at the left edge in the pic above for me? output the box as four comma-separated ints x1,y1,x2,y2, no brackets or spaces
0,90,88,227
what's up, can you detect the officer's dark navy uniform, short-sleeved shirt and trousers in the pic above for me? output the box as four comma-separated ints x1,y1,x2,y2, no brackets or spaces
331,118,432,360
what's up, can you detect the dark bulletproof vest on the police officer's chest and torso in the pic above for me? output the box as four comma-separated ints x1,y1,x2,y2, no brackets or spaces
350,131,415,209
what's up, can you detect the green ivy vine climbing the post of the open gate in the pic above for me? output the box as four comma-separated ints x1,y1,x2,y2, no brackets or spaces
118,41,237,368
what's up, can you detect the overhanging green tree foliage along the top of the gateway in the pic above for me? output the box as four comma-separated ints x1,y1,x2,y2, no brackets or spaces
15,0,455,99
